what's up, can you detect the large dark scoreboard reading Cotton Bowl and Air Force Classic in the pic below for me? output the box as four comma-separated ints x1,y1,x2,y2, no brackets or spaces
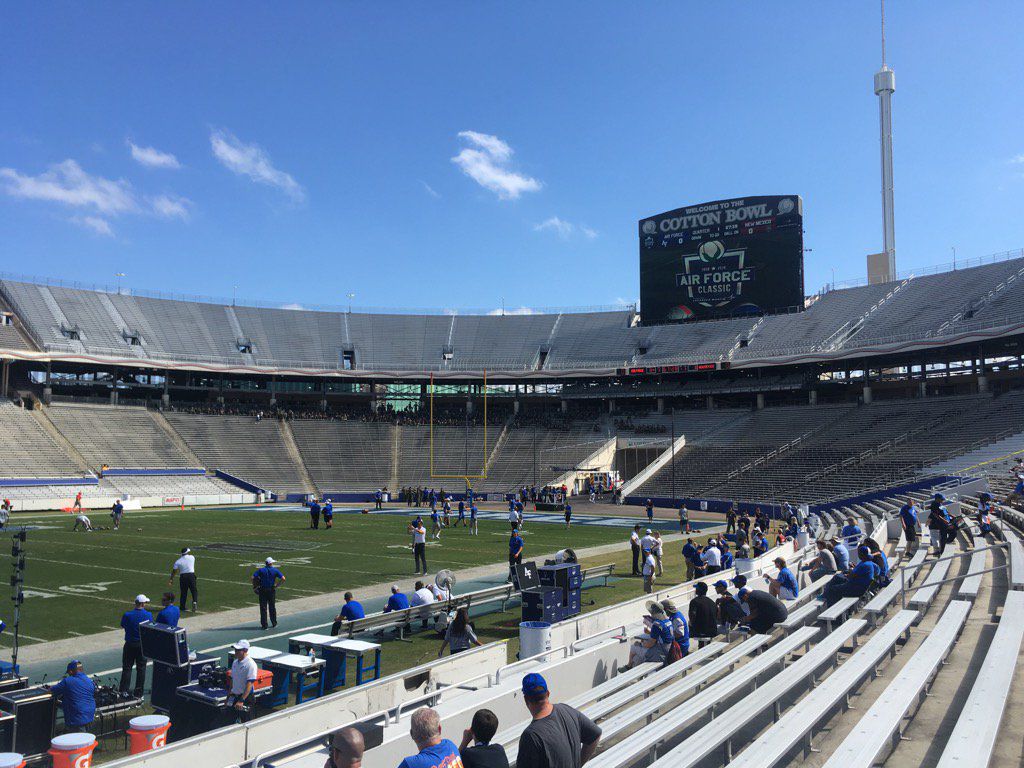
638,195,804,325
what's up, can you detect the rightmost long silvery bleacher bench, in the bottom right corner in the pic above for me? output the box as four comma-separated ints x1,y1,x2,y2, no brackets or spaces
938,592,1024,768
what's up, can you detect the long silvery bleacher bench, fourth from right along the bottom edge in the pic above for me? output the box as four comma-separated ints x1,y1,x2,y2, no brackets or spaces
650,618,867,768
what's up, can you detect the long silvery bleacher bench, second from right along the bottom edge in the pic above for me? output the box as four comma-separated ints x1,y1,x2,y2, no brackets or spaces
824,600,971,768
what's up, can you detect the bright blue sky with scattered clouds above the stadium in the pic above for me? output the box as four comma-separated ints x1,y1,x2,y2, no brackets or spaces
0,0,1024,308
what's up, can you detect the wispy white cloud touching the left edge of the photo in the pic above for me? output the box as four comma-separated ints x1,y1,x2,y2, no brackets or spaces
0,160,138,216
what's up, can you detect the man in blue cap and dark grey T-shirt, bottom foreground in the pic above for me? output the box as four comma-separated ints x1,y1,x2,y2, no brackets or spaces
516,672,601,768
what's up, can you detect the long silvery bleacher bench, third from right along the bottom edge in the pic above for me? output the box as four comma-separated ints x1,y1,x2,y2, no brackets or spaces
730,610,918,768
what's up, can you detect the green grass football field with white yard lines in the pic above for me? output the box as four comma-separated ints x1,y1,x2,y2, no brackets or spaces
0,508,627,646
